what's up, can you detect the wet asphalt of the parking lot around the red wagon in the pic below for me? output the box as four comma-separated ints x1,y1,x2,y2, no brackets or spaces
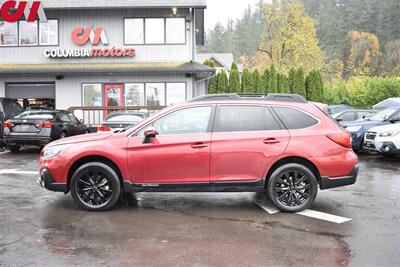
0,149,400,266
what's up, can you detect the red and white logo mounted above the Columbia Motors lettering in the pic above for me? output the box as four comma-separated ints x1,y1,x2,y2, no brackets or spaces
71,27,108,46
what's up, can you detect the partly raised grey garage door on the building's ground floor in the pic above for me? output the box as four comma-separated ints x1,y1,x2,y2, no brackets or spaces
6,83,56,99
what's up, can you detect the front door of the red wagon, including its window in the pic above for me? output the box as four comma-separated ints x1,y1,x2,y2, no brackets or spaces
128,106,213,186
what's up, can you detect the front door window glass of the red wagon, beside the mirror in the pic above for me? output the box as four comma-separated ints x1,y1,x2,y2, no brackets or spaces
138,107,212,136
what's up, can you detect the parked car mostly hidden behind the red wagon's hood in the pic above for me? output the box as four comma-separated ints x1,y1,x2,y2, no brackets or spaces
97,111,149,132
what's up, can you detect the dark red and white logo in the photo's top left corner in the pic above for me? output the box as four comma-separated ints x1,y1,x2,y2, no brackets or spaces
0,0,47,23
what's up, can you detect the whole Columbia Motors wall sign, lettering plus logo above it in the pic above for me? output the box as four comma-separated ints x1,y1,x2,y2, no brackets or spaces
45,27,136,58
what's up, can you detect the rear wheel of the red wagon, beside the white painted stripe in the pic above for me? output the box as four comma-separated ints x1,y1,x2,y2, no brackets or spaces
267,163,318,212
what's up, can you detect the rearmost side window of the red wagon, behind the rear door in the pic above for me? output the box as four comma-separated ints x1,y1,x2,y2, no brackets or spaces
274,107,318,129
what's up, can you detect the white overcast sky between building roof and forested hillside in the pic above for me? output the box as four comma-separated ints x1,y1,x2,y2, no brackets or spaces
205,0,258,29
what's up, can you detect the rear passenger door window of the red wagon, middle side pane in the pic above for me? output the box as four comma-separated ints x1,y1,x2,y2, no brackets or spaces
214,106,280,132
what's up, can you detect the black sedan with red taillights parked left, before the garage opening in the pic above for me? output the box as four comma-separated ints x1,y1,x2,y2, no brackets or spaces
4,110,89,152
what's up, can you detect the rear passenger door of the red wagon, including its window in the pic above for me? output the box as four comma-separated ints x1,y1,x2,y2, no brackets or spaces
210,105,290,183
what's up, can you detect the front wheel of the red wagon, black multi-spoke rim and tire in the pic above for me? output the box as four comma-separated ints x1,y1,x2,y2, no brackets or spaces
70,162,122,211
